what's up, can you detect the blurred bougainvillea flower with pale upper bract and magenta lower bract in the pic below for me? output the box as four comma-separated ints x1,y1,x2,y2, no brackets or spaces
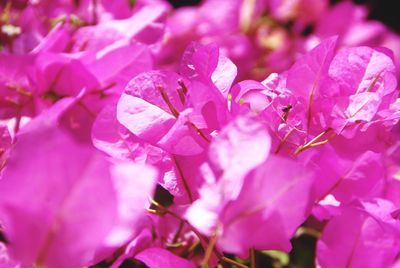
186,114,312,257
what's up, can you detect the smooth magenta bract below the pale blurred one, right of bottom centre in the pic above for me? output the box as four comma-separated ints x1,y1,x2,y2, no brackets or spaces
218,157,313,256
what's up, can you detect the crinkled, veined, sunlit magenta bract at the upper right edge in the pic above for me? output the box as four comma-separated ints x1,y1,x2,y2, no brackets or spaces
329,47,397,137
